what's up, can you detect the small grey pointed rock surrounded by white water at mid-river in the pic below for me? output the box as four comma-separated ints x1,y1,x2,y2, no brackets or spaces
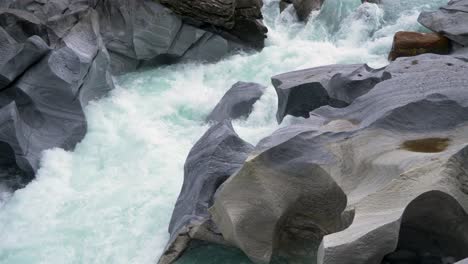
206,82,266,122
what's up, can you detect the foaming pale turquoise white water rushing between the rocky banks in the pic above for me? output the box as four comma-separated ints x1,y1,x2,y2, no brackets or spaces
0,0,447,264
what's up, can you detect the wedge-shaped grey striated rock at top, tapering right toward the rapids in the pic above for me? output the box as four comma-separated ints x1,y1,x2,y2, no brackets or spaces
96,0,240,74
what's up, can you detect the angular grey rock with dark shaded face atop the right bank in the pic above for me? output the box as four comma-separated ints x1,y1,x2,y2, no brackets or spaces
272,64,389,123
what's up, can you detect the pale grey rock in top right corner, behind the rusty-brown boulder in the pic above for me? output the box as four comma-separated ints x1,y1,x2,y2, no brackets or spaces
418,0,468,46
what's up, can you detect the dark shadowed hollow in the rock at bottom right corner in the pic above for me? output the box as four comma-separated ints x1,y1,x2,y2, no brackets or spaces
382,191,468,264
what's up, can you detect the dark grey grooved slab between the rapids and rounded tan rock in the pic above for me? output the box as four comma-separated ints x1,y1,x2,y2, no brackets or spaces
159,120,253,264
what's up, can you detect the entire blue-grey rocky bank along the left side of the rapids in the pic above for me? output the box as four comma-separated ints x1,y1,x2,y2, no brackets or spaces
0,0,264,189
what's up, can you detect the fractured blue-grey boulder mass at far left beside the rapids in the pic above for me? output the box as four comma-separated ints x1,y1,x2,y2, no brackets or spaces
0,9,113,189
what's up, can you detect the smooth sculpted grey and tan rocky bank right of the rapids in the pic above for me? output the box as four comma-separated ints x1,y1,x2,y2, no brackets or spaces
160,0,468,264
